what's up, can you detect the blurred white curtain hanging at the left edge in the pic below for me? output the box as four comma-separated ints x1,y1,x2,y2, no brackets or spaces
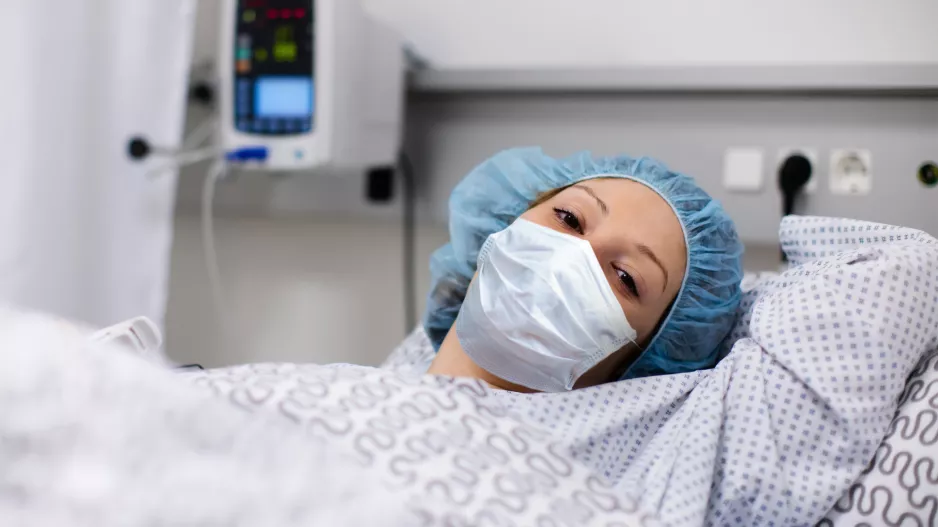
0,0,195,325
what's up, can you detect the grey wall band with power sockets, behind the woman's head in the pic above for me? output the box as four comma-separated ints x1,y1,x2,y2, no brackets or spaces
180,94,938,244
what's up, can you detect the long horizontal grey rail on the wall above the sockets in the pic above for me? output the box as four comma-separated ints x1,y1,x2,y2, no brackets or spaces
410,64,938,96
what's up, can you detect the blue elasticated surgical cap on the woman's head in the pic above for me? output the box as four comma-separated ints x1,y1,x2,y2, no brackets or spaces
423,148,743,379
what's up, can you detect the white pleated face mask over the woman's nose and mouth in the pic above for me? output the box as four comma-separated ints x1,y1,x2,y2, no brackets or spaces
456,219,636,392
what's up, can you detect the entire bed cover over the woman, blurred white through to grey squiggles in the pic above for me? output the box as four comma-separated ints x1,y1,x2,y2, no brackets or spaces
0,311,659,527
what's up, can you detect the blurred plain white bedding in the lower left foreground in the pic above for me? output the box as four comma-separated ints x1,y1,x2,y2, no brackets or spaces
0,309,398,527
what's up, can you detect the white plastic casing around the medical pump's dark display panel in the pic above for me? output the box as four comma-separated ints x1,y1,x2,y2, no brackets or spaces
219,0,405,174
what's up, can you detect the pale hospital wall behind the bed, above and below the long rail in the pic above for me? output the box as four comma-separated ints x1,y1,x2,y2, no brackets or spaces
167,0,938,365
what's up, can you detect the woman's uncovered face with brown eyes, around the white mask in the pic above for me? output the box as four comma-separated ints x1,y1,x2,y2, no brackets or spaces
521,178,687,387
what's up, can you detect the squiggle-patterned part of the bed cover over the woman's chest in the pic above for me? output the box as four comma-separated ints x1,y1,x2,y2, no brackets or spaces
183,364,658,527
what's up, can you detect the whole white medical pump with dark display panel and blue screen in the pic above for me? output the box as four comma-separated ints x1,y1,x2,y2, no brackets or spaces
219,0,405,171
